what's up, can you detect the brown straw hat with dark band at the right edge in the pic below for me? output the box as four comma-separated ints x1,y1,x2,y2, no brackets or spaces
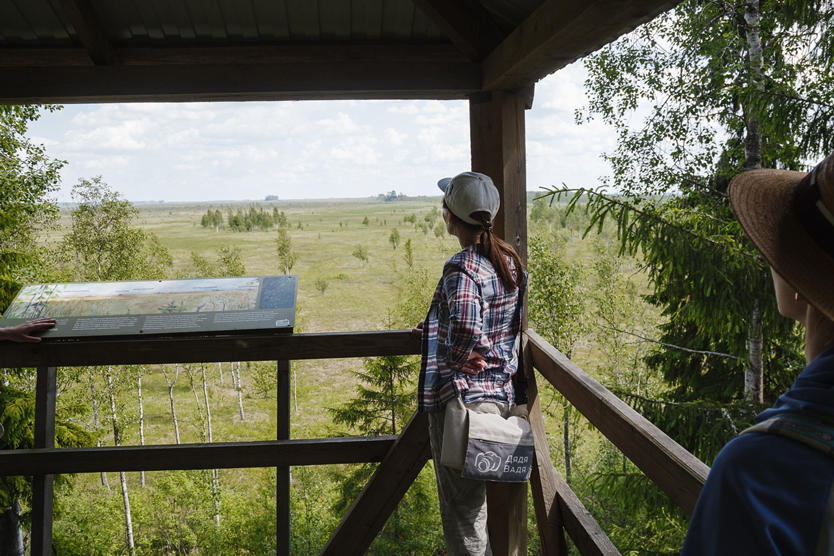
730,154,834,320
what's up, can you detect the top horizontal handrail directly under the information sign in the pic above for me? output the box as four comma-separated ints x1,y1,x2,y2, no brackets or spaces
0,330,420,367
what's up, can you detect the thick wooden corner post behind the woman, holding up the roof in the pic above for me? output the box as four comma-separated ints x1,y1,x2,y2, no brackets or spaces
469,91,530,556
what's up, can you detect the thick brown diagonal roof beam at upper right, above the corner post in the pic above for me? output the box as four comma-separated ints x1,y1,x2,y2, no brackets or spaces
482,0,680,91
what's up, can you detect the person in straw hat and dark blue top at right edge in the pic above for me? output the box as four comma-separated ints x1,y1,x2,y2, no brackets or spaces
681,154,834,556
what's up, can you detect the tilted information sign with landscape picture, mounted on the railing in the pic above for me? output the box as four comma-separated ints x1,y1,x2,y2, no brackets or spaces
0,276,298,338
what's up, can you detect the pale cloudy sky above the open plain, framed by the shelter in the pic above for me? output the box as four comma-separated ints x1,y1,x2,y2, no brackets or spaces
28,62,615,202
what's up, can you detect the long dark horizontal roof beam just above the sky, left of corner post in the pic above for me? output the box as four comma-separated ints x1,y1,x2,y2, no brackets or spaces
0,61,481,104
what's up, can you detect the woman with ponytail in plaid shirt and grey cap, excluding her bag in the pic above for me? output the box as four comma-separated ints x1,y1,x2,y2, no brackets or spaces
414,172,527,556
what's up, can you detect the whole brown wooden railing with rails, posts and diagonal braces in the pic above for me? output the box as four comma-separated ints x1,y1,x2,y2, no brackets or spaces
0,331,709,556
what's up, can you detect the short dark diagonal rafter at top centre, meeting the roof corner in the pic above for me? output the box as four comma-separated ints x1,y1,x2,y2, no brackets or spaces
412,0,504,61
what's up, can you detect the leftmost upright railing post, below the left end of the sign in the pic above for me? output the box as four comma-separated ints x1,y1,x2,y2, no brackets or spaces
31,367,58,556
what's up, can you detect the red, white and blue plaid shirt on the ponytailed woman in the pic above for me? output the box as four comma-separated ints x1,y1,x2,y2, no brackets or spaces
418,245,527,413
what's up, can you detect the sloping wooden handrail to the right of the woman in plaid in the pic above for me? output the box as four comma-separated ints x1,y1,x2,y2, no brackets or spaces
526,330,709,515
